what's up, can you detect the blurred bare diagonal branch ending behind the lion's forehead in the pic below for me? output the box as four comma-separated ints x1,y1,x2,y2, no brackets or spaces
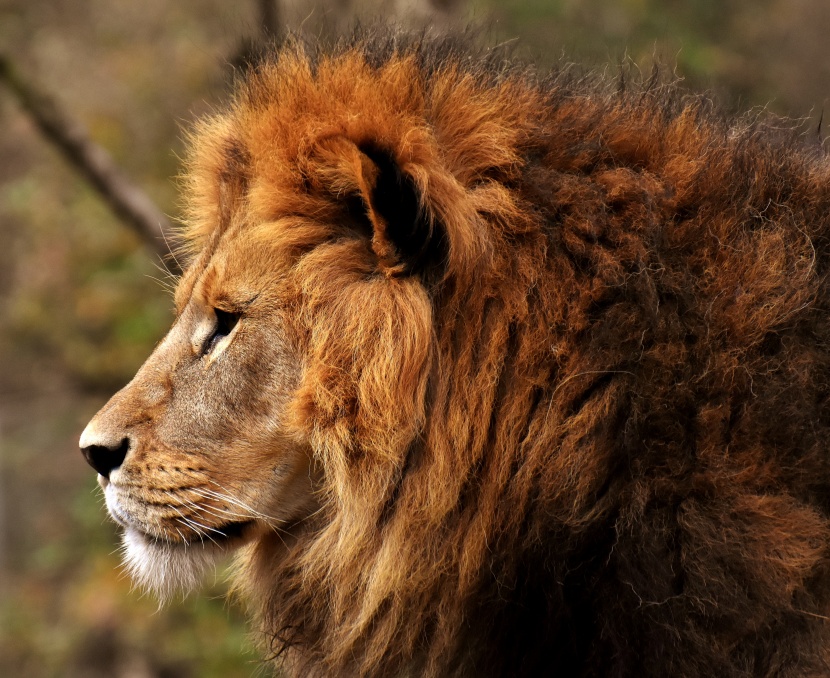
0,54,178,273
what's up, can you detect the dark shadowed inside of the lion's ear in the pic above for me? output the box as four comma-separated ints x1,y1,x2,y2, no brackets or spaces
353,144,443,275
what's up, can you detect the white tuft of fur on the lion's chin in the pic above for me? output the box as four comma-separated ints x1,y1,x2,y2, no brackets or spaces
123,527,223,602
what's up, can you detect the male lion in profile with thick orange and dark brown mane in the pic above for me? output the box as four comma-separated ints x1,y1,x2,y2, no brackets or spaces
80,32,830,678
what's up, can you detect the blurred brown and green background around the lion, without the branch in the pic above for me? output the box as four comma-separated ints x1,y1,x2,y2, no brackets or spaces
0,0,830,678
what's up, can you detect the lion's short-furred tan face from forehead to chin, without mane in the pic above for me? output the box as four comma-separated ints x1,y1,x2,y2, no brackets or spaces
81,233,313,596
